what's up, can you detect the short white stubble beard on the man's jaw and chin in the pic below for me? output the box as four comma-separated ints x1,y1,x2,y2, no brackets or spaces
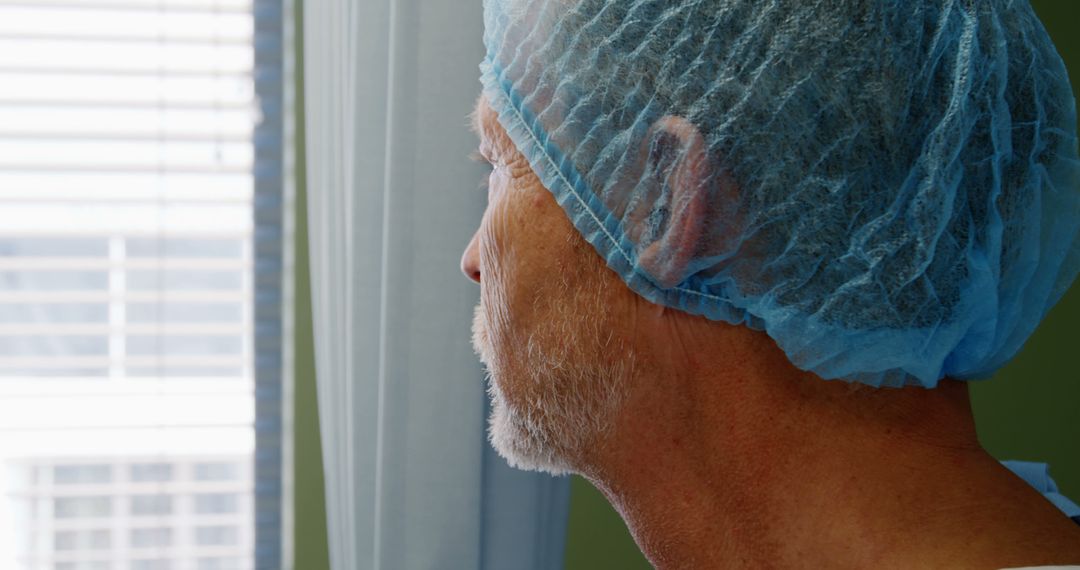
472,278,634,475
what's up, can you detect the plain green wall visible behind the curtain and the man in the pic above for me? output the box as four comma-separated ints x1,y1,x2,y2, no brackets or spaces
295,0,1080,570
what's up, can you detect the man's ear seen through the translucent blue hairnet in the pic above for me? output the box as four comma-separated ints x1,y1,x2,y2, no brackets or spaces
626,116,712,289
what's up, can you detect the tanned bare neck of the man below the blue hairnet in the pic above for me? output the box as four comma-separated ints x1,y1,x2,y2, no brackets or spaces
582,338,1080,569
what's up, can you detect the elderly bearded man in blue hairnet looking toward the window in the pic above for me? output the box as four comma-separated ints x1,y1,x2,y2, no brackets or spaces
462,0,1080,568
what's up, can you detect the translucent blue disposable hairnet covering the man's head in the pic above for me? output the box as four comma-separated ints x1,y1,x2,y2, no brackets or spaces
481,0,1080,388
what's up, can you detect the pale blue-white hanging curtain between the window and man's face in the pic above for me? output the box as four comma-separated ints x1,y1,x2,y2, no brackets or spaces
303,0,569,570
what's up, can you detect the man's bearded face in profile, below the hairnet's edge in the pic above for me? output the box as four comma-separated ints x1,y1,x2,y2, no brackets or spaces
461,98,637,473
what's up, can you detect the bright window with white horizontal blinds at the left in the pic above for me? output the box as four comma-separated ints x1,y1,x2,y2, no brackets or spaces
0,0,281,570
